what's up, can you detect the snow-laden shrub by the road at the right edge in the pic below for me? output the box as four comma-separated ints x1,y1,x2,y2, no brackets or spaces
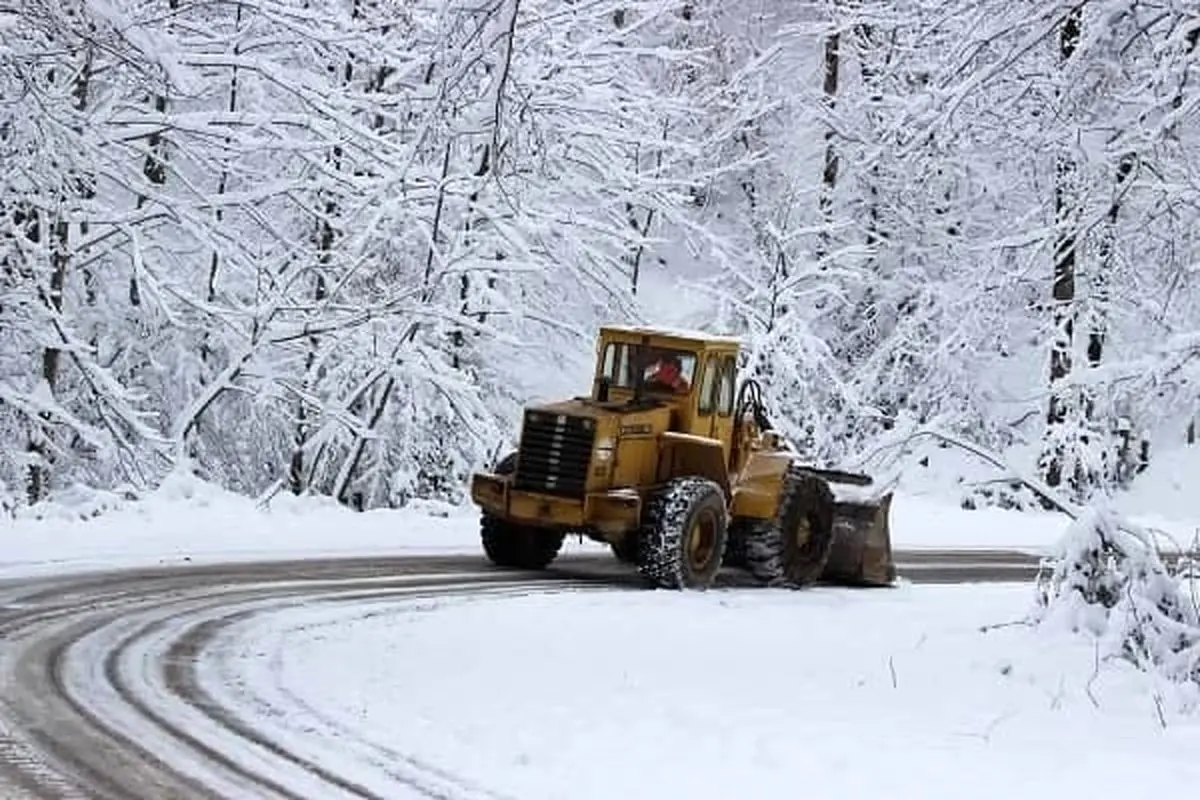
1034,509,1200,685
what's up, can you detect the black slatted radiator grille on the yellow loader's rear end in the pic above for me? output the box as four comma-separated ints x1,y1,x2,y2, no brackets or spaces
514,411,595,498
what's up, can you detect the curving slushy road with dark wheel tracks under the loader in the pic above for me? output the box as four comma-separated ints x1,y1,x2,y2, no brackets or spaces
0,551,1037,800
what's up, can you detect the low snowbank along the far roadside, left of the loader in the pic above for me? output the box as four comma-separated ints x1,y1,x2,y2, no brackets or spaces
0,475,476,575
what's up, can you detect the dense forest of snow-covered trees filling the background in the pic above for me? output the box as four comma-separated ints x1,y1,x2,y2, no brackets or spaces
0,0,1200,507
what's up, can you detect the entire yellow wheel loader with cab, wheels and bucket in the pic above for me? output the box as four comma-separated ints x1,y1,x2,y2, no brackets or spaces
470,325,895,589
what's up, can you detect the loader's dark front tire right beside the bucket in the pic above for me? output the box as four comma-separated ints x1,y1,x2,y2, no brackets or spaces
746,467,834,589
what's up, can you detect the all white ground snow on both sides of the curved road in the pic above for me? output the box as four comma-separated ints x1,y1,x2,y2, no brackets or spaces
0,448,1200,800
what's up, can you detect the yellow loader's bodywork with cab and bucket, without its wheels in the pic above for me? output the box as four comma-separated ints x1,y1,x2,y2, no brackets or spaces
470,326,895,584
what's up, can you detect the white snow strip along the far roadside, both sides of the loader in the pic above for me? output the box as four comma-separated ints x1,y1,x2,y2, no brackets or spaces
0,449,1200,576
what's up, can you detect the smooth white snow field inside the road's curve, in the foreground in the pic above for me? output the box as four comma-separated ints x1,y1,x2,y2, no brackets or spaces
206,585,1200,800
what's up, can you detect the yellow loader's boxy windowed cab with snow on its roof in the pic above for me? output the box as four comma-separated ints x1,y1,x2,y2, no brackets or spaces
592,326,739,457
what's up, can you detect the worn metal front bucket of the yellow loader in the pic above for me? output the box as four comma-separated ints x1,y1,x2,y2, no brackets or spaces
814,470,896,587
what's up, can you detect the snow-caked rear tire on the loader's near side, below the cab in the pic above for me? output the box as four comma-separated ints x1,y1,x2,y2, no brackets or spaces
637,477,728,589
